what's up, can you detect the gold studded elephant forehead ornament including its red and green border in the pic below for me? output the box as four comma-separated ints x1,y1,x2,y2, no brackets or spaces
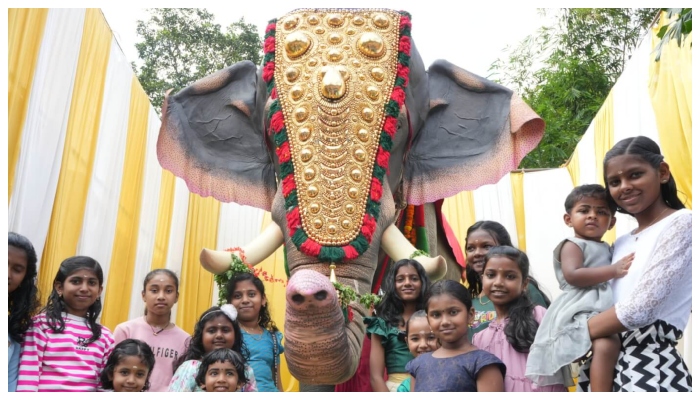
263,10,410,262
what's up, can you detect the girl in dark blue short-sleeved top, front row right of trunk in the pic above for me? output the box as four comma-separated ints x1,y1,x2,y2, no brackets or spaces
406,279,506,392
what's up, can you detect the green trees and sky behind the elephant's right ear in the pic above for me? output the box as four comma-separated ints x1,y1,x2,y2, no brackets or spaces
490,8,658,168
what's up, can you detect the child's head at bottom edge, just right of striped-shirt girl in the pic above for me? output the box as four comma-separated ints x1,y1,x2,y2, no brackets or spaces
100,339,156,392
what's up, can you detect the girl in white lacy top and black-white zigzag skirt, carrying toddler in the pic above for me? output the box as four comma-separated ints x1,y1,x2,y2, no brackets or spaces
579,136,693,391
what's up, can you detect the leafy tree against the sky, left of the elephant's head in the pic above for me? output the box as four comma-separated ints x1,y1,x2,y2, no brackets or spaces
132,8,262,112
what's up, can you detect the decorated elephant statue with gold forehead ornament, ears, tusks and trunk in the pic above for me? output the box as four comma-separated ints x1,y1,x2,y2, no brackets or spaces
157,9,544,385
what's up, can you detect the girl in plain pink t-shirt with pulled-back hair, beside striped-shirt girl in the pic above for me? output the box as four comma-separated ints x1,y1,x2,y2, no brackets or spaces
114,269,190,392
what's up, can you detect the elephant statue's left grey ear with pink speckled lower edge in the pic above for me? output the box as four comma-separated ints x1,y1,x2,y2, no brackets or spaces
157,61,276,211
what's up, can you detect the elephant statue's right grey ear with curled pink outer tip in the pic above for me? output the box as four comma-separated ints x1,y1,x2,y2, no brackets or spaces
404,60,544,204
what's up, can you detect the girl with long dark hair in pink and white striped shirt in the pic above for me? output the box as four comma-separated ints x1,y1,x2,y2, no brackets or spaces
17,256,114,392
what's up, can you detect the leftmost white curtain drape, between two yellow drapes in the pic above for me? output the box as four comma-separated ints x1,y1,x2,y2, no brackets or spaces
7,9,85,256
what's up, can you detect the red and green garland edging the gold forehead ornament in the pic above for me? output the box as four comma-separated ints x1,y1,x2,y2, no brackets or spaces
263,11,411,262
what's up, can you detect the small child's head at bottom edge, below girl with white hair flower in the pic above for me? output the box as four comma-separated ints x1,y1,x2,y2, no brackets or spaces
196,349,248,392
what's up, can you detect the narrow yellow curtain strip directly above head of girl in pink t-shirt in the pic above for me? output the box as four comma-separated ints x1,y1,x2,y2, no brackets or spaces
151,169,175,269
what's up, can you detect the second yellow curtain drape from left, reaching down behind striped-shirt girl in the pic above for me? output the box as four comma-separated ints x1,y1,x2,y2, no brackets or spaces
39,9,112,300
